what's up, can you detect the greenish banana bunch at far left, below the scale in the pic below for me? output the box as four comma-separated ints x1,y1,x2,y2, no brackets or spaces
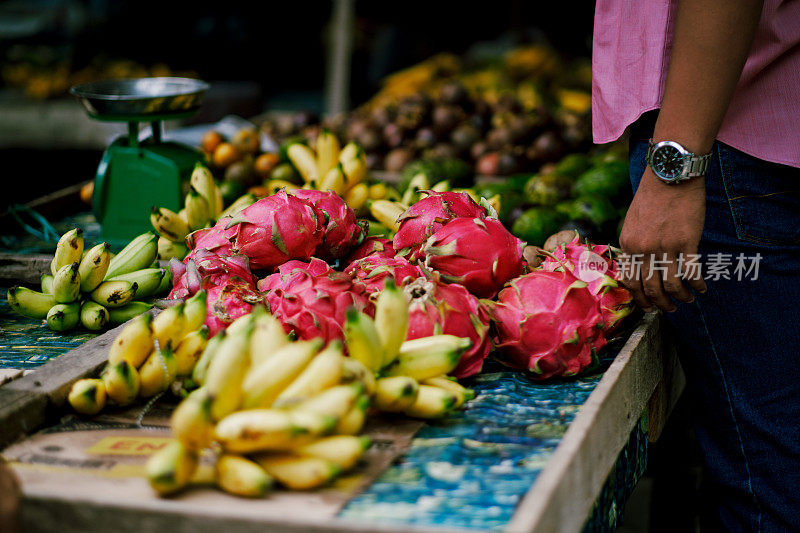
8,228,171,331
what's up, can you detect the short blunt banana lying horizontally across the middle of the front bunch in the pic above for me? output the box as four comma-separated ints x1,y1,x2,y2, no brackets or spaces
214,409,297,453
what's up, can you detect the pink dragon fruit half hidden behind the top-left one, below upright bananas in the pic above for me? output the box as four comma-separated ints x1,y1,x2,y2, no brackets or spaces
291,189,368,259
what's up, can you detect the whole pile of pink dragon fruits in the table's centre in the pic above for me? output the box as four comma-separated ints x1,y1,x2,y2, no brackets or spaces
170,190,631,379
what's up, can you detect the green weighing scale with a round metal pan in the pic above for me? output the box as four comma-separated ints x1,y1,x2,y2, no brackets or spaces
70,78,209,244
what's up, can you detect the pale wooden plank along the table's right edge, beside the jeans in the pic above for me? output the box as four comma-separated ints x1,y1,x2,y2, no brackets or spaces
505,313,662,533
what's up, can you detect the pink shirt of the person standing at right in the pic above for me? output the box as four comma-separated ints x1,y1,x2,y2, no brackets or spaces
592,0,800,167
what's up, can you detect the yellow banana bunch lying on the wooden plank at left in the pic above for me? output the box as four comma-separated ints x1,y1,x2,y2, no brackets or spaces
68,291,208,415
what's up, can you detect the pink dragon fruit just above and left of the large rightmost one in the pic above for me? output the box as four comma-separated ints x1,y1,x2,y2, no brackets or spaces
421,218,525,298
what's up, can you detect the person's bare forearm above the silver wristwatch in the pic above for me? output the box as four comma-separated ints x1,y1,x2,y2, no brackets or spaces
653,0,763,154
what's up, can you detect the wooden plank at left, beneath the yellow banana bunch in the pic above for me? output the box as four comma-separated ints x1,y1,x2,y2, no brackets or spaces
0,316,134,449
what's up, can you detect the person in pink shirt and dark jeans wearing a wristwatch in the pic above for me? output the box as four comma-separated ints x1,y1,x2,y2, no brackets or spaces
592,0,800,531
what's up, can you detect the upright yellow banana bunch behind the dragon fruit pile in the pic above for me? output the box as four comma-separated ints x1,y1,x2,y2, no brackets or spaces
287,130,380,212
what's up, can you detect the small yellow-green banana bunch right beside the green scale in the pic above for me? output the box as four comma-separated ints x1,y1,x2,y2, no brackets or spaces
150,163,223,261
